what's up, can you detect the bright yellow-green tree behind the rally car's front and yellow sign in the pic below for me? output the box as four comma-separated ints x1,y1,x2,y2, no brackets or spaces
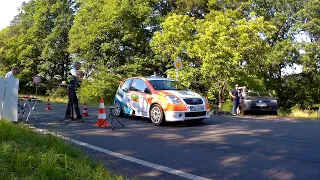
151,11,274,106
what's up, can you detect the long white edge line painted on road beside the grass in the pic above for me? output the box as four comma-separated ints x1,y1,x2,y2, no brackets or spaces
33,128,210,180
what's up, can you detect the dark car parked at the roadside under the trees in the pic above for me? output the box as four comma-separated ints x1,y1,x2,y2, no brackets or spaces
240,91,278,115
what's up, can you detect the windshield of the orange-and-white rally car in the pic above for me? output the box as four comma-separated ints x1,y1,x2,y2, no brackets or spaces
149,80,187,90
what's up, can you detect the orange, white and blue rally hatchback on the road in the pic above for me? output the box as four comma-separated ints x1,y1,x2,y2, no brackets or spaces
114,76,210,125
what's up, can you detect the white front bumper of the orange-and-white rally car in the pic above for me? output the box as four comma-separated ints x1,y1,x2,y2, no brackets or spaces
164,110,210,122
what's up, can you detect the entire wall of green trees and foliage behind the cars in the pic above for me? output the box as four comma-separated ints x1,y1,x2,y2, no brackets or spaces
0,0,320,108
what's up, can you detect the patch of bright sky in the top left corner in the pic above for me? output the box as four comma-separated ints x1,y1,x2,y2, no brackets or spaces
0,0,28,30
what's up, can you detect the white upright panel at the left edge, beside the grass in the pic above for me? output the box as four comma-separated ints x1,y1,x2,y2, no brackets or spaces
0,77,19,121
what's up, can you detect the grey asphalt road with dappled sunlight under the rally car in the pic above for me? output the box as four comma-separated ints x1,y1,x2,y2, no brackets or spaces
26,104,320,180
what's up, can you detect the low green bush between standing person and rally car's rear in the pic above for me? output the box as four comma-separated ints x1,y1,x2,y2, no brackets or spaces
79,69,122,104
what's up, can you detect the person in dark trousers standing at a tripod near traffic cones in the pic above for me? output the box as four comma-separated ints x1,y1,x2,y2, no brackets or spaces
65,62,83,120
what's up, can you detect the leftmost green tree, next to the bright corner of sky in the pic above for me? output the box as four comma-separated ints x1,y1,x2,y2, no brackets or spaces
0,0,74,93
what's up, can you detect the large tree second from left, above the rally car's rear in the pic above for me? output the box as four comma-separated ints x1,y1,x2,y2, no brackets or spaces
69,0,158,74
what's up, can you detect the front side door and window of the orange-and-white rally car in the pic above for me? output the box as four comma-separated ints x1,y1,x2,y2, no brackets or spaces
130,78,148,116
